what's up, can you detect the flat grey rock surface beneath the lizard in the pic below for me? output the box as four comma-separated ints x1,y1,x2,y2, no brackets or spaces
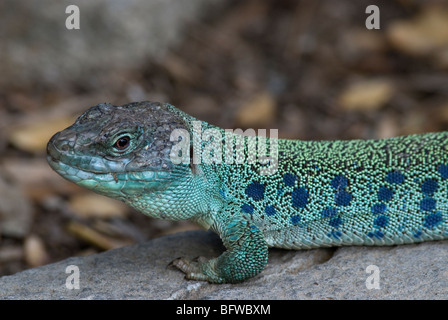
0,231,448,300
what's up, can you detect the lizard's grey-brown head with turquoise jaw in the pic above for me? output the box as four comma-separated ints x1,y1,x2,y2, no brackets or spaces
47,102,194,202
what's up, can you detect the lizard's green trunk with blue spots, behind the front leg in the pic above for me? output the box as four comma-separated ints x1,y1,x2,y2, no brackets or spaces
211,132,448,249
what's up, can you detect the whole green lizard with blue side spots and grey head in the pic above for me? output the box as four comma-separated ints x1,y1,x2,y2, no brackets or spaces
47,101,448,283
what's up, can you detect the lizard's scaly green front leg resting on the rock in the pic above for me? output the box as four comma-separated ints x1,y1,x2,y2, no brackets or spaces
173,207,268,283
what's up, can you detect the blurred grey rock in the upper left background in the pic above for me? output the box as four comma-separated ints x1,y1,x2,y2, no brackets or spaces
0,0,223,87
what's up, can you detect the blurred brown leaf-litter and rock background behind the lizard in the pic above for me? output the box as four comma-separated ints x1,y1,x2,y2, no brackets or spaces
0,0,448,276
